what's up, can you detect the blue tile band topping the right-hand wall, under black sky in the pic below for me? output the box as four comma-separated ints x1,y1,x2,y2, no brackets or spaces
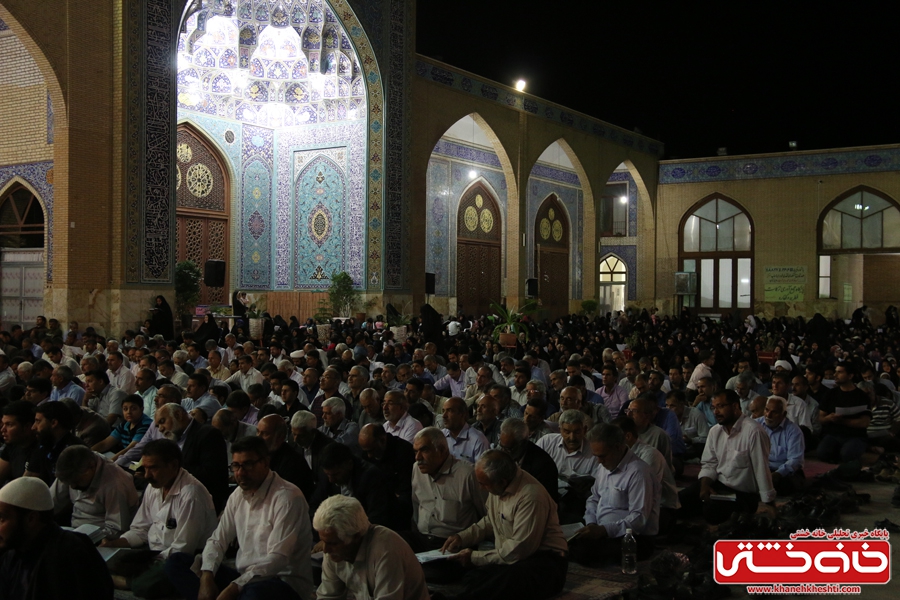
659,147,900,184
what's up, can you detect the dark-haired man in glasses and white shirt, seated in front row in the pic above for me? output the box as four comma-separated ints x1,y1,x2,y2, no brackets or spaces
165,437,313,600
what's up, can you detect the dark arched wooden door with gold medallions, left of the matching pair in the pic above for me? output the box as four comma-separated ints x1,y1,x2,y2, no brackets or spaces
456,183,503,315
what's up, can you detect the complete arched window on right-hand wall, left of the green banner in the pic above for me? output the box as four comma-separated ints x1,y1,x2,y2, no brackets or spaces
679,194,753,314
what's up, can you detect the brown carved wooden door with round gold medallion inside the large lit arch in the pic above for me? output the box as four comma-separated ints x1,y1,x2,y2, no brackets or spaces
175,124,231,304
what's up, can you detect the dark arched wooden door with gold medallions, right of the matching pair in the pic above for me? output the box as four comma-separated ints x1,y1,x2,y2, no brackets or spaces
534,194,569,318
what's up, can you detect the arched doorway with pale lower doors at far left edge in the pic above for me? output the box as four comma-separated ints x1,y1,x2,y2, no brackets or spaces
0,184,45,329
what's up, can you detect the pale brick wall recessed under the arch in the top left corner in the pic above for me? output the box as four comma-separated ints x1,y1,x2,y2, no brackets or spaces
0,31,53,165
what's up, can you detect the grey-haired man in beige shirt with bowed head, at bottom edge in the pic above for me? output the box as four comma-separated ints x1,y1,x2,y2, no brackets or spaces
313,495,430,600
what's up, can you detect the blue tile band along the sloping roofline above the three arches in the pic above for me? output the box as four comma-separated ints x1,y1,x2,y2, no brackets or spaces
415,56,665,156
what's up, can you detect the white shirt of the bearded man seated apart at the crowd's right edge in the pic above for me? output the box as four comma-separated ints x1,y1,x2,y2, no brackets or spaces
699,415,775,502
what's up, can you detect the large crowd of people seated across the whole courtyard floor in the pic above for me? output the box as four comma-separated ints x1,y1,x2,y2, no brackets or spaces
0,300,900,600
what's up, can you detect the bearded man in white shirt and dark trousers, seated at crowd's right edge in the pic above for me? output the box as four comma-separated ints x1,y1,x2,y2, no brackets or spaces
678,390,775,525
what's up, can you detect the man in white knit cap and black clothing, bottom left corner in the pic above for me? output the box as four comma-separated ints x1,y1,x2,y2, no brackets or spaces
0,476,113,600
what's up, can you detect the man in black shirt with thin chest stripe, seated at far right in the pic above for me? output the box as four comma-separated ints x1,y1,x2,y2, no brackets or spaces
816,363,872,463
